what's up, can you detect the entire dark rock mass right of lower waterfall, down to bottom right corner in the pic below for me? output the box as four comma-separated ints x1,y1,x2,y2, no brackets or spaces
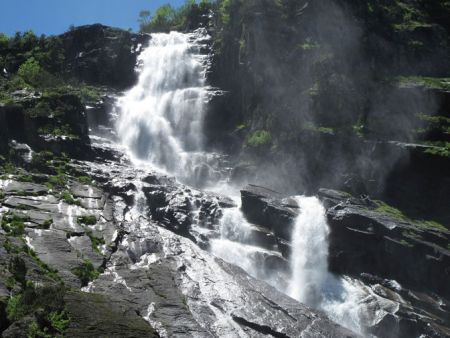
319,189,450,337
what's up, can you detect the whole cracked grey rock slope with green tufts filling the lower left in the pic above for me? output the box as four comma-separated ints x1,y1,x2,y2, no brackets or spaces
0,139,357,337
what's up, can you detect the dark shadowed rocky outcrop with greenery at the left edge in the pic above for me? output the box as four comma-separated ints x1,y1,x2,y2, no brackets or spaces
0,90,90,157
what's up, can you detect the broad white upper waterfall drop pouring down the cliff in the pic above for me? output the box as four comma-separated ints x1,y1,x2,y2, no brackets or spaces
116,30,208,182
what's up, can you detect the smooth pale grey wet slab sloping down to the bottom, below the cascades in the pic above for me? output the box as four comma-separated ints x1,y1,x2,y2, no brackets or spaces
85,219,356,337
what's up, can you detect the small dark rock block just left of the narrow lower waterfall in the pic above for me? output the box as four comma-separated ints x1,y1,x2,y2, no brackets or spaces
241,185,299,240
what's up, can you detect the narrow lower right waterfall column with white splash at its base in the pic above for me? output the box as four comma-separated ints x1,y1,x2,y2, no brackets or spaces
288,196,367,333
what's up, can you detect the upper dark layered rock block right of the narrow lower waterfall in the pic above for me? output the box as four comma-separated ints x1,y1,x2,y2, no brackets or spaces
322,190,450,298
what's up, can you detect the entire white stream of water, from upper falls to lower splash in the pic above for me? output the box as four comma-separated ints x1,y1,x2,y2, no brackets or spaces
116,30,372,332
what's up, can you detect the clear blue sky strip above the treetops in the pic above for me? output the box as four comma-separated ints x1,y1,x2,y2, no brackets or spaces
0,0,184,35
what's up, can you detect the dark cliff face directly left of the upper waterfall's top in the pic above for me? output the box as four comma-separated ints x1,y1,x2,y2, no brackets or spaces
61,24,149,89
